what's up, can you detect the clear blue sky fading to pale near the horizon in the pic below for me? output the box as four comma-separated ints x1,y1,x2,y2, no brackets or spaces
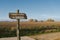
0,0,60,20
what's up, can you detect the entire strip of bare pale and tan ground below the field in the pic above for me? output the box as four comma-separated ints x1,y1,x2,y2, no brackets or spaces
0,32,60,40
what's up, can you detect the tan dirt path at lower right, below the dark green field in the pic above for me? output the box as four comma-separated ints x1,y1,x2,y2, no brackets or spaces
31,32,60,40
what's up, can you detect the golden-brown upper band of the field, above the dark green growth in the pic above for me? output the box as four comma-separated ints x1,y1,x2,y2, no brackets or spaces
0,22,60,29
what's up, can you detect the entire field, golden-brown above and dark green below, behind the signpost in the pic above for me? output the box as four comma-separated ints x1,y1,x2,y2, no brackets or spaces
0,22,60,38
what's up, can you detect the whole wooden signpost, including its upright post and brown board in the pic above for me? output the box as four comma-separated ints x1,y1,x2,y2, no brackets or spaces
9,10,27,40
